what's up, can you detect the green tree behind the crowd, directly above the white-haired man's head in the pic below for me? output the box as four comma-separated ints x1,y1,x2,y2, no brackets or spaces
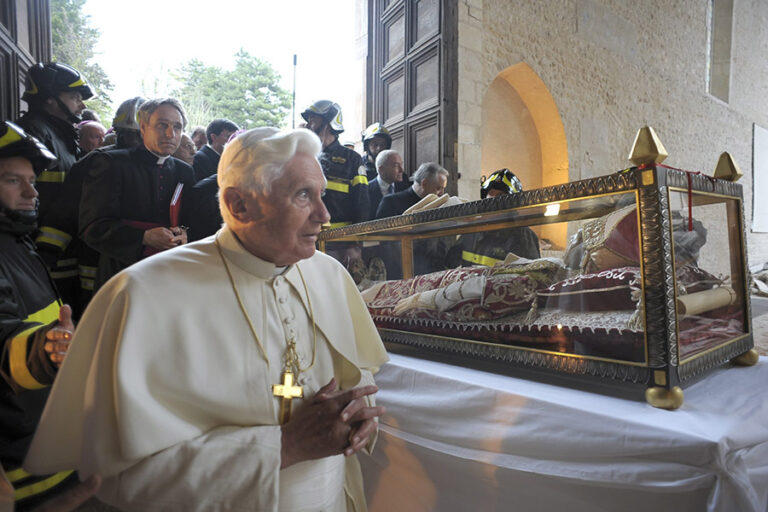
174,49,291,129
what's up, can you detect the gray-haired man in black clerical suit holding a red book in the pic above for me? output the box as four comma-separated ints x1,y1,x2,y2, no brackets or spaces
78,98,195,292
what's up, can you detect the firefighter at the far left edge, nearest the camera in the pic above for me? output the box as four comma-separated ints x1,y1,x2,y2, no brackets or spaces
0,122,78,510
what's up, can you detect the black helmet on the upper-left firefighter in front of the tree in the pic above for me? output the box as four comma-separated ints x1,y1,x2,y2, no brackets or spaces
21,62,93,103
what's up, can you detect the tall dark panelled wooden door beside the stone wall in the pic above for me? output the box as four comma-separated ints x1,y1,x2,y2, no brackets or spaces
366,0,458,194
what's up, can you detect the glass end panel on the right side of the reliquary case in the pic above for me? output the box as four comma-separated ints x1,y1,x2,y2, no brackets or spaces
670,191,747,360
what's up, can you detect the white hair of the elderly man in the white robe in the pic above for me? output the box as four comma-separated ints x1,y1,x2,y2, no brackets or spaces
217,128,322,224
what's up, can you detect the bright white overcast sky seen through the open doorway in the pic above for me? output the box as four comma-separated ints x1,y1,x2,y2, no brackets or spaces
84,0,362,130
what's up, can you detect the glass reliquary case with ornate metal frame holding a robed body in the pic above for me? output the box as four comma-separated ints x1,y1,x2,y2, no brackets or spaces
320,136,756,409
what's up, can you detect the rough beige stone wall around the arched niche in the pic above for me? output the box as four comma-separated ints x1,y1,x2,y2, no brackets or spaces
458,0,768,264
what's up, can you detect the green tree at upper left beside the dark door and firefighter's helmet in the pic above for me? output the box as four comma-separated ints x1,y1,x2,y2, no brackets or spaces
51,0,113,124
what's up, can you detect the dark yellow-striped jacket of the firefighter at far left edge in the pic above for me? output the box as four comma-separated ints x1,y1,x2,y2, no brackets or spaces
0,213,77,510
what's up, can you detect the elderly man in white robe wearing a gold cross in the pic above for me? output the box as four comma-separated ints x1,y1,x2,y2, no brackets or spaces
25,128,387,511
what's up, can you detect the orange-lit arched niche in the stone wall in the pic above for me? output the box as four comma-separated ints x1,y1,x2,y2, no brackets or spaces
481,62,568,250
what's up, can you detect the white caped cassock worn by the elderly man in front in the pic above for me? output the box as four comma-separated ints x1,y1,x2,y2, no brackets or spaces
25,227,387,511
